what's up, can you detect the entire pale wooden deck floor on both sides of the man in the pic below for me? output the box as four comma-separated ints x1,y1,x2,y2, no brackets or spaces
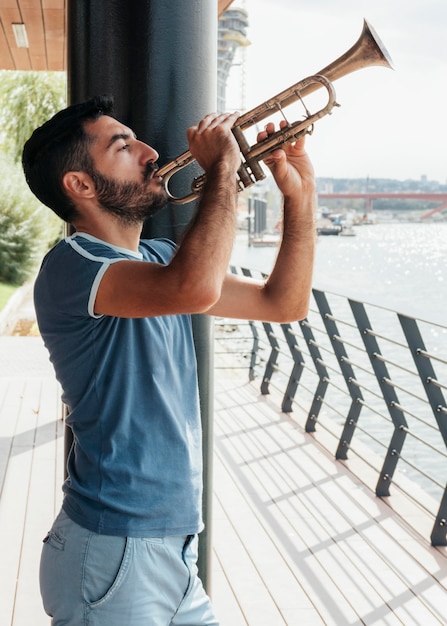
0,337,447,626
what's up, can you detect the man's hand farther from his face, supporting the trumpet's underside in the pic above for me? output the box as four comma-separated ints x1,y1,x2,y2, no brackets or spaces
258,121,315,197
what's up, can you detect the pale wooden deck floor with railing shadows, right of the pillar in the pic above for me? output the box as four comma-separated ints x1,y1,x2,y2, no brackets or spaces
213,380,447,626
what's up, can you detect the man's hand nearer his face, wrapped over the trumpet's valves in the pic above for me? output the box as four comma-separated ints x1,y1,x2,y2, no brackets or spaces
186,113,241,176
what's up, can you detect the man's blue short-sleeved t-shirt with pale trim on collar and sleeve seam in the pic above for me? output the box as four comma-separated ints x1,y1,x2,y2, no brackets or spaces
34,233,202,537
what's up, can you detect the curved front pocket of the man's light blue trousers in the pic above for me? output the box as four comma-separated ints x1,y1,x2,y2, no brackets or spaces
83,533,131,608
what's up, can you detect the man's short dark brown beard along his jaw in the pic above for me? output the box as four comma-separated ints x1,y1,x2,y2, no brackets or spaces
90,163,168,226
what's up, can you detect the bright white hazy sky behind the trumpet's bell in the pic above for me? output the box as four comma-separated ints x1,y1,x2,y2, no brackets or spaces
226,0,447,184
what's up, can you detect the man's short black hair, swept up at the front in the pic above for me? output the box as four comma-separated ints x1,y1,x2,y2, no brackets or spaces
22,96,113,222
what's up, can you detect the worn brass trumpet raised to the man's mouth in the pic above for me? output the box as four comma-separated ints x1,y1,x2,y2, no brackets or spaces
157,20,393,204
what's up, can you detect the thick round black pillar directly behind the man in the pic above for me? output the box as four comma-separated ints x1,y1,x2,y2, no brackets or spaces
68,0,218,591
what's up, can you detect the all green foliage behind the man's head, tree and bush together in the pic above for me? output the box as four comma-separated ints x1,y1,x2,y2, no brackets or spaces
0,70,66,285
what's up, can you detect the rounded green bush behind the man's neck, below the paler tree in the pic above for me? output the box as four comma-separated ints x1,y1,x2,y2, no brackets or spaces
0,156,62,285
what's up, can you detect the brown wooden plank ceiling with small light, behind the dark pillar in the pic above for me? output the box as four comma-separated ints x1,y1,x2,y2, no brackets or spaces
0,0,233,71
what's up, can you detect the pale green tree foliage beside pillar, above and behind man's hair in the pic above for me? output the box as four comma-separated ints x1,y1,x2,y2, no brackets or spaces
0,70,66,161
